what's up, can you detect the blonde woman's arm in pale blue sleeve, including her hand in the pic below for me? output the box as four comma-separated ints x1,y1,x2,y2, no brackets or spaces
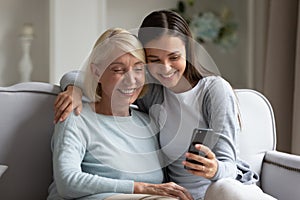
52,114,193,200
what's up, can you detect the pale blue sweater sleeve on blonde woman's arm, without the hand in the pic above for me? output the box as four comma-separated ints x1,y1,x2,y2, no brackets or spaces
52,114,134,199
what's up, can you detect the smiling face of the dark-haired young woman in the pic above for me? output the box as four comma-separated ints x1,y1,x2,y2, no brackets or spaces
145,35,186,88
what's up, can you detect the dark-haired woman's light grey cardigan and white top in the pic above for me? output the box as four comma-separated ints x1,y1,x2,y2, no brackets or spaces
137,76,258,199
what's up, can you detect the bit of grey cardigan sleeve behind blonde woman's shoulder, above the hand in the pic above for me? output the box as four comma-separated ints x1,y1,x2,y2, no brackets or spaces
60,70,84,91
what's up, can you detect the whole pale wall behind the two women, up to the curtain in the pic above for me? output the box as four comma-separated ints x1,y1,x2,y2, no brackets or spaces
0,0,267,88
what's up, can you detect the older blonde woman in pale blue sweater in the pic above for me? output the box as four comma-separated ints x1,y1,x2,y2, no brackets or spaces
48,29,192,200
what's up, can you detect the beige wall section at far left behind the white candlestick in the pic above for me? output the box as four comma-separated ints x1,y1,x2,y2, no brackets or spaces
0,0,49,86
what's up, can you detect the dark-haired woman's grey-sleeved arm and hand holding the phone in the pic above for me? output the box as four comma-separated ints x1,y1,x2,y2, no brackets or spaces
183,77,240,181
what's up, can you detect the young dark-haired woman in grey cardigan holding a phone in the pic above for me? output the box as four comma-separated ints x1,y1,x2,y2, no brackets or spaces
55,10,273,200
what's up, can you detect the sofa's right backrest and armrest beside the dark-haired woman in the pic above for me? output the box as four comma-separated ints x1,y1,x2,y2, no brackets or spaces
235,89,300,200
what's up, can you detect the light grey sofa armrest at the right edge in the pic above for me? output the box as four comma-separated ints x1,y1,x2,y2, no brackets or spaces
261,151,300,200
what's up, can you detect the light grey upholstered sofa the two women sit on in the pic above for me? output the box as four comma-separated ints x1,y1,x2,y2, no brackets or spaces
0,82,300,200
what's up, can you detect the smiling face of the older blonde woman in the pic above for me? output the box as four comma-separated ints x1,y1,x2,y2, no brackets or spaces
99,53,145,105
